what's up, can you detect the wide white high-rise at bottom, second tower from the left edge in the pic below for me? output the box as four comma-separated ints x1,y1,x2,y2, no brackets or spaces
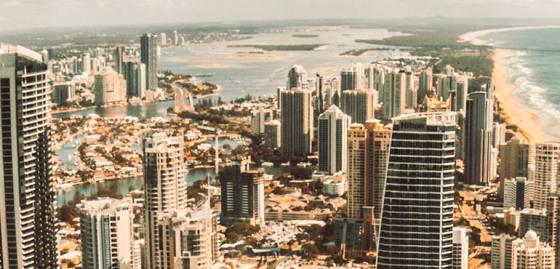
78,198,134,269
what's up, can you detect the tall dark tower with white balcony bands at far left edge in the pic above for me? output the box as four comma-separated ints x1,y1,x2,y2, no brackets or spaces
0,44,58,269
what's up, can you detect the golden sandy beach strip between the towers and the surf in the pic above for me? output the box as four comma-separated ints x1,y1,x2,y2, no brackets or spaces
492,49,551,143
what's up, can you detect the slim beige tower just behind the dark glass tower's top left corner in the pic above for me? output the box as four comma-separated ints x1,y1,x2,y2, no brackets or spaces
379,69,406,120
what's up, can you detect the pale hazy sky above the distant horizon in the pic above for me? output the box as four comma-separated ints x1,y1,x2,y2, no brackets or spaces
0,0,560,30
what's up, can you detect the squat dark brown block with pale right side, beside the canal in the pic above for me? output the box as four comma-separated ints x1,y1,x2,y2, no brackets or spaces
220,160,264,225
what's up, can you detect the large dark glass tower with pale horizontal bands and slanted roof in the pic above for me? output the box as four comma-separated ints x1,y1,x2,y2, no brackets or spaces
377,112,456,269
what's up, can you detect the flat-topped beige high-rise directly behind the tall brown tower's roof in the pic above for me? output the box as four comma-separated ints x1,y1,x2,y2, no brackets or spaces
341,89,378,124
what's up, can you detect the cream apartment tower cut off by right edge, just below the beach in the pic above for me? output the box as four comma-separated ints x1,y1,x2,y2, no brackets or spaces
534,143,560,209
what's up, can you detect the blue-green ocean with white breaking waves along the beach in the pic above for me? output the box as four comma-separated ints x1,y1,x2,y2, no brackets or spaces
482,29,560,139
